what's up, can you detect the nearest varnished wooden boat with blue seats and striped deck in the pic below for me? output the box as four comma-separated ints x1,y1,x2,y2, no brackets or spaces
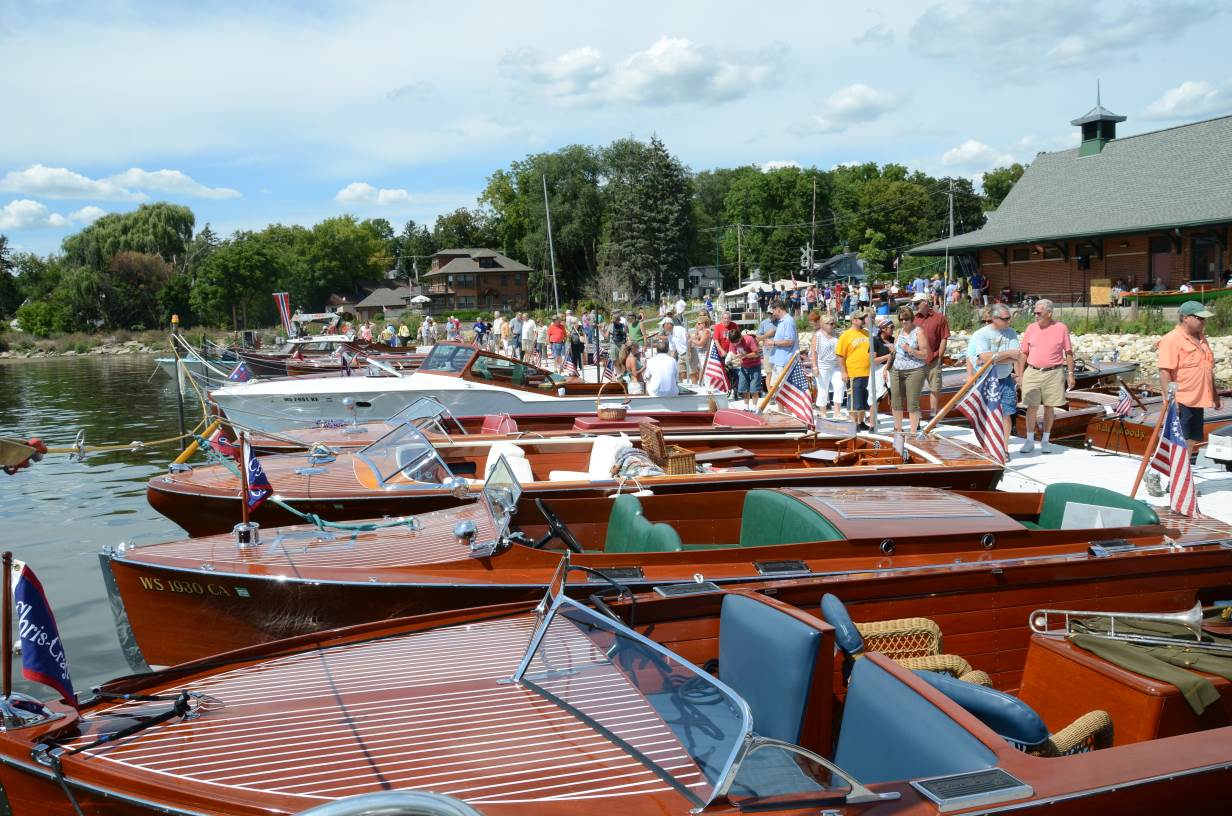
9,525,1232,816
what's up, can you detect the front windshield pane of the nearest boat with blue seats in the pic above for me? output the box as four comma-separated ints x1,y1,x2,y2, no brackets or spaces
513,594,753,806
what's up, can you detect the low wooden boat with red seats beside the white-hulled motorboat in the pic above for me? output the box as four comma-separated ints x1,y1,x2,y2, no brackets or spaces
250,397,808,454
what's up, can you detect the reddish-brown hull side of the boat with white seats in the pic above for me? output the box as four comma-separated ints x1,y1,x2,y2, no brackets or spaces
147,460,1002,537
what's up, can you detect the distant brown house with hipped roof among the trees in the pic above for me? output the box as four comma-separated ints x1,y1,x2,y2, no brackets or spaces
421,249,533,314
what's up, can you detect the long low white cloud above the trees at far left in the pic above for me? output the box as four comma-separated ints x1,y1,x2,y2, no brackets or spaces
0,164,239,201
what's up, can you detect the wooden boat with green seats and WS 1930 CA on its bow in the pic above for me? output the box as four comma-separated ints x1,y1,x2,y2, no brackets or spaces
100,468,1192,668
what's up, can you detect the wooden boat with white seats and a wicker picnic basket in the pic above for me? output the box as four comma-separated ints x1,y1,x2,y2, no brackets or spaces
147,416,1002,535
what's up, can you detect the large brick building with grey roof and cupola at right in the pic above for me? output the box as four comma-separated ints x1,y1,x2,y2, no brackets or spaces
909,105,1232,303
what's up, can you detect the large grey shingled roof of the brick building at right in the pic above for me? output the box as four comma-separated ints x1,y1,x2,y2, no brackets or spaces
909,116,1232,255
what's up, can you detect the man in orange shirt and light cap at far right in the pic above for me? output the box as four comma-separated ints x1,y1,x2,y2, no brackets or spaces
1158,301,1218,457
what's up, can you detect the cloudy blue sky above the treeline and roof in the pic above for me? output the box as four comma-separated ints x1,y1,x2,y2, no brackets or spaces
0,0,1232,254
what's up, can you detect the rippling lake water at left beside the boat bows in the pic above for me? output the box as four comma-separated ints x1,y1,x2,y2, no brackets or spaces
0,355,189,698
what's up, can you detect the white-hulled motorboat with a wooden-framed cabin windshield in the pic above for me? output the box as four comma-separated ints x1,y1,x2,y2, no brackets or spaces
209,343,727,431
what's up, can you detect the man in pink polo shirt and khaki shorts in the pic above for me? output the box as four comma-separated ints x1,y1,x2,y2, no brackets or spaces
1015,300,1074,454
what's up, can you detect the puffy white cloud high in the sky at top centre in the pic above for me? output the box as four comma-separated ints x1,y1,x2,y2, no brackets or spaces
501,36,781,106
